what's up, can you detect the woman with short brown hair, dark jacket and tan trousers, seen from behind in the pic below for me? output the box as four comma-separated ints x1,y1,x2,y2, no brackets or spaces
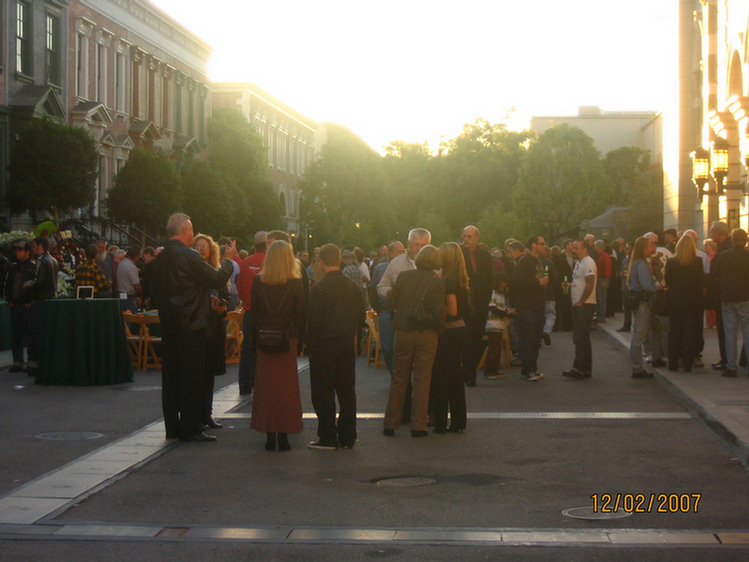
383,244,445,437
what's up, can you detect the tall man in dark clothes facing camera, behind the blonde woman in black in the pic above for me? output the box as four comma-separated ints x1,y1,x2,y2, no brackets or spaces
461,225,492,386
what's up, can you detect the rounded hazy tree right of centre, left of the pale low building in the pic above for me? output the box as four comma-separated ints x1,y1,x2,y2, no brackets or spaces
511,124,612,236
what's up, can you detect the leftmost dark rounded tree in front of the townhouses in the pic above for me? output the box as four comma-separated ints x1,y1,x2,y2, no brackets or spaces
6,117,99,219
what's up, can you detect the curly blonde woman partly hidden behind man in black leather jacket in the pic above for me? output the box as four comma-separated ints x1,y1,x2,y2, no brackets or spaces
192,234,230,429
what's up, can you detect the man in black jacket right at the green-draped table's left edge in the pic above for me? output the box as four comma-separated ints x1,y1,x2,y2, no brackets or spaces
24,237,57,377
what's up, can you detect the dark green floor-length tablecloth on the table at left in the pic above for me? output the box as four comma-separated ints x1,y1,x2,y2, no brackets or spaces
36,299,133,386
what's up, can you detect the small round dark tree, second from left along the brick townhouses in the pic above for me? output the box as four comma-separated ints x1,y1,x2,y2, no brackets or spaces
107,148,182,244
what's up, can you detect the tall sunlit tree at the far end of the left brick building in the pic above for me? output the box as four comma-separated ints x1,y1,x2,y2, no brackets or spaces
205,108,282,234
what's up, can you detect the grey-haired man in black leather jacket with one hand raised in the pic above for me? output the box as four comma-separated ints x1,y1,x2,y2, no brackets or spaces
150,213,236,442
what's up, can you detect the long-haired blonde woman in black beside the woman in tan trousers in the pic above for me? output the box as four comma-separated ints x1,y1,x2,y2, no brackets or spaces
430,242,469,433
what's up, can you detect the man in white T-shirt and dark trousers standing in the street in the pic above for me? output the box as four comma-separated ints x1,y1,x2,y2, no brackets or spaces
562,240,598,379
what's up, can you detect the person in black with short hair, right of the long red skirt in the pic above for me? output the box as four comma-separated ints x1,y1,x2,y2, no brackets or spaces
307,244,364,451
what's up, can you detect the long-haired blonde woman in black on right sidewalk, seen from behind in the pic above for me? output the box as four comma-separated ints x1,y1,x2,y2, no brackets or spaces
665,232,705,372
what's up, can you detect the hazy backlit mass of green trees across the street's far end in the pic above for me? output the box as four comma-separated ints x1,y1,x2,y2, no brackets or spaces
302,119,662,248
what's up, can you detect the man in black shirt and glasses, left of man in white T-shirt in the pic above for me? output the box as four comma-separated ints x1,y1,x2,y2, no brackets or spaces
511,232,549,382
